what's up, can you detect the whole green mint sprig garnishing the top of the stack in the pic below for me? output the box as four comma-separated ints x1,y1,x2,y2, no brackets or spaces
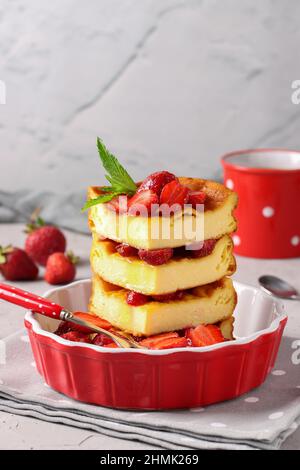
82,137,137,211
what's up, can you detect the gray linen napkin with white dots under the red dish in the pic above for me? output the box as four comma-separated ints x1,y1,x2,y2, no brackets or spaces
0,330,300,449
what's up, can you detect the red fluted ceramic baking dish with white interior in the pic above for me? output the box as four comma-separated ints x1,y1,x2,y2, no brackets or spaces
25,280,287,410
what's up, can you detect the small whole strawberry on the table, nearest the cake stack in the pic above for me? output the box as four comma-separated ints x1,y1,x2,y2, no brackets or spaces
45,253,78,284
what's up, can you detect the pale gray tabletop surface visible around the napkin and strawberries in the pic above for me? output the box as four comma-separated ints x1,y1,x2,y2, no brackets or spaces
0,224,300,450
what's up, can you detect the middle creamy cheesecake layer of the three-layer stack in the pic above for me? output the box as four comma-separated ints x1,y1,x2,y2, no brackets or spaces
91,235,236,295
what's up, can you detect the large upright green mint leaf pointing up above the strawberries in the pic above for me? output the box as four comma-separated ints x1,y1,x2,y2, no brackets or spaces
97,137,137,194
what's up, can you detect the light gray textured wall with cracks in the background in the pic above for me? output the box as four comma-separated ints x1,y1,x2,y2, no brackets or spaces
0,0,300,192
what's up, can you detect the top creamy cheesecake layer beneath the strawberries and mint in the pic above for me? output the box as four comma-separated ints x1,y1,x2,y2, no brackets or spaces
88,177,237,250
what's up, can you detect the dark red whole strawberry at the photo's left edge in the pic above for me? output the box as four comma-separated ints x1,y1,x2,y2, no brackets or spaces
0,245,39,281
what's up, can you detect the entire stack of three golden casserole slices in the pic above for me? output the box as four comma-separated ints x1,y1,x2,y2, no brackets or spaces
88,177,237,339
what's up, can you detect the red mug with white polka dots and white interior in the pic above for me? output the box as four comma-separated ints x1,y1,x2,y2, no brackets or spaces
222,149,300,258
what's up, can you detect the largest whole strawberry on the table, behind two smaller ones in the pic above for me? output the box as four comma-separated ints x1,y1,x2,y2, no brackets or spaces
25,217,66,266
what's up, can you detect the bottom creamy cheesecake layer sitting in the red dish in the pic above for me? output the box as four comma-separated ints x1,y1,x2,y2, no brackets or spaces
89,276,237,336
